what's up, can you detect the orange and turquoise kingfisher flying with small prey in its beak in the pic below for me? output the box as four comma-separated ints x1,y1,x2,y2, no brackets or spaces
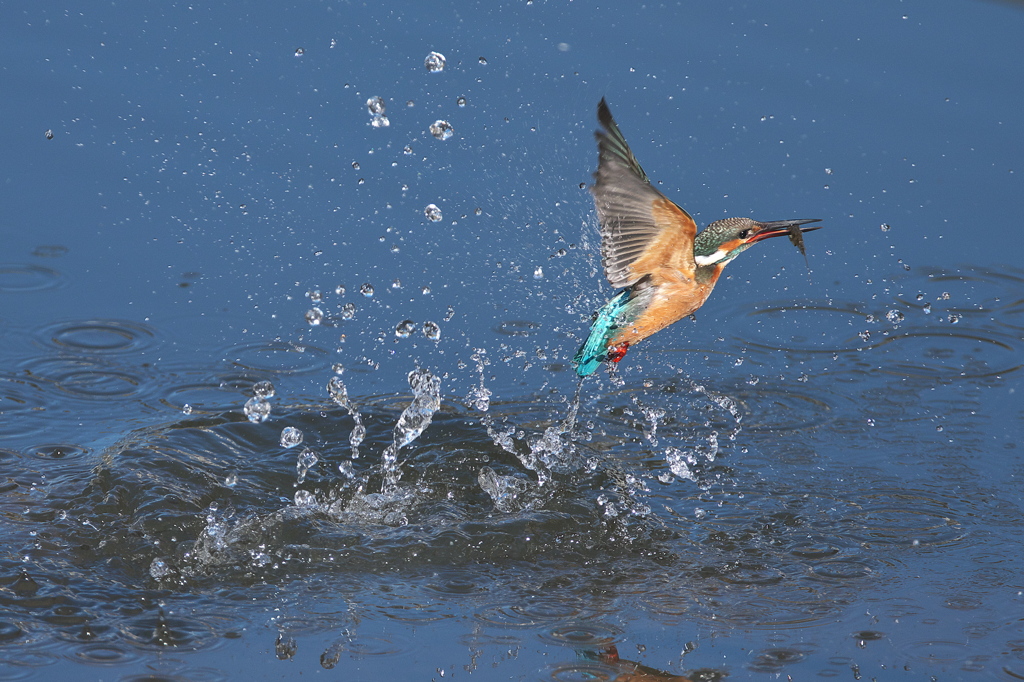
572,97,823,377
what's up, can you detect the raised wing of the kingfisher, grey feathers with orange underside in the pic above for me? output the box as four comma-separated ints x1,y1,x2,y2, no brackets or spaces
590,97,697,289
